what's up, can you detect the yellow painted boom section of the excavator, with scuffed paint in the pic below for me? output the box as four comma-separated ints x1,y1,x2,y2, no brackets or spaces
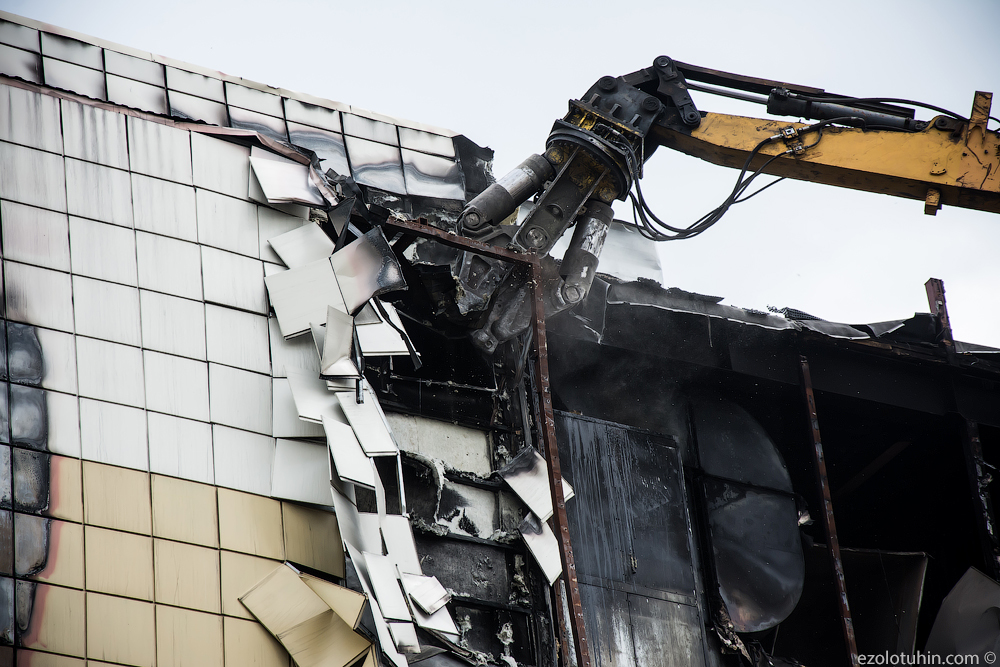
646,100,1000,214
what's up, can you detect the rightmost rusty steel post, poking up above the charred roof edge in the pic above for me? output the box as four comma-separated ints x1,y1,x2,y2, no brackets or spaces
924,278,1000,579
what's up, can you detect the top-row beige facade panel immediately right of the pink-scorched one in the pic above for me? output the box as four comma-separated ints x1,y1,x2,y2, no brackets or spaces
83,461,153,535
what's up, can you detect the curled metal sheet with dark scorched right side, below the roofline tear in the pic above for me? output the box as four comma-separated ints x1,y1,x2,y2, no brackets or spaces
330,227,406,313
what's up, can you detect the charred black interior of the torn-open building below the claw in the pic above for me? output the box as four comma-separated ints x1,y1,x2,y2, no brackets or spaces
300,142,1000,665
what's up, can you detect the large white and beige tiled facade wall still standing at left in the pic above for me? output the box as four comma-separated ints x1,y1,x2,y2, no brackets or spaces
0,81,340,665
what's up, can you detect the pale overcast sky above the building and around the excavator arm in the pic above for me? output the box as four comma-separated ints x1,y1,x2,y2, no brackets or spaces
7,0,1000,347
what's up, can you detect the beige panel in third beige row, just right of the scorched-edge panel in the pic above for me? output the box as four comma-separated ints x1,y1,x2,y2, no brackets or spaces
87,593,156,667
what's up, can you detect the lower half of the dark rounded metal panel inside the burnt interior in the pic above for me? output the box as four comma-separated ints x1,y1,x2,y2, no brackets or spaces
702,478,805,632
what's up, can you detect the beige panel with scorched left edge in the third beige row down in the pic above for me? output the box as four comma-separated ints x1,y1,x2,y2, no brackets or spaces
20,584,84,657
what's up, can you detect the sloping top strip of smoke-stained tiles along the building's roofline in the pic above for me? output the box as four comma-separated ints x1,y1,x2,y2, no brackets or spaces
0,14,465,200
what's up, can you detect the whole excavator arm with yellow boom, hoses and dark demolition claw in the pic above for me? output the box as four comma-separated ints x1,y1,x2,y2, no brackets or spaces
457,56,1000,352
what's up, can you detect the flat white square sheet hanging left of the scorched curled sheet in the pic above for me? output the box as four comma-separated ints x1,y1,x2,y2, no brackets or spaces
264,258,348,338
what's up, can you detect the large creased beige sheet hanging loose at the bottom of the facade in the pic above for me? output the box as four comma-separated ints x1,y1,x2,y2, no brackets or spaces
240,565,371,667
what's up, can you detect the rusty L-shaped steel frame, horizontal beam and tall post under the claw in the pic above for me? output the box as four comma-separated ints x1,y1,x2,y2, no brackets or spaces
384,218,591,667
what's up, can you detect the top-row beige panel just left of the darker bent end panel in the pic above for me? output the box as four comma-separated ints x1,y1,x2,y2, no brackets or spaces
219,488,284,560
